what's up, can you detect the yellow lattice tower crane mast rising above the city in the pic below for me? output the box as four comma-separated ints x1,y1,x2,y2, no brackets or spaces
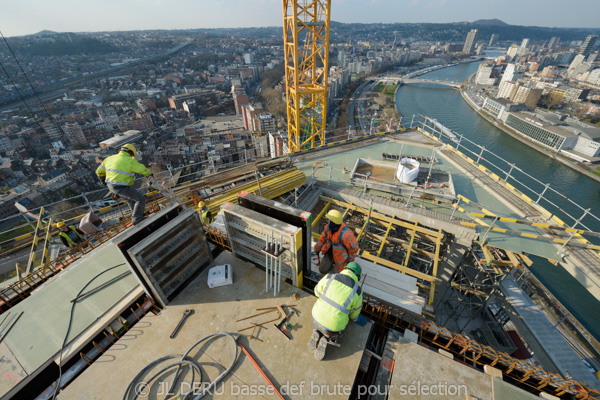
283,0,331,153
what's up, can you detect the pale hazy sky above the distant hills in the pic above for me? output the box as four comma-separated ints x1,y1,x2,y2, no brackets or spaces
0,0,600,36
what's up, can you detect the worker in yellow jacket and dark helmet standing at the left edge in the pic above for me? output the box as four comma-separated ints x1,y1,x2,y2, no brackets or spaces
96,144,152,225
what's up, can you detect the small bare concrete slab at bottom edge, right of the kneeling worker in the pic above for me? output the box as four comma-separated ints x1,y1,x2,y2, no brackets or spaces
388,339,538,400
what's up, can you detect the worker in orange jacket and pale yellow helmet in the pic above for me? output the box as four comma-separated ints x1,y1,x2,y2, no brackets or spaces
315,210,358,274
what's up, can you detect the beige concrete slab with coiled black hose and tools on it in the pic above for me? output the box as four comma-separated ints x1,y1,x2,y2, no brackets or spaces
60,252,371,400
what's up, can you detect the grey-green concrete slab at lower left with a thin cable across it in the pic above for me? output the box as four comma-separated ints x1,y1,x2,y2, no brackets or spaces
0,242,141,396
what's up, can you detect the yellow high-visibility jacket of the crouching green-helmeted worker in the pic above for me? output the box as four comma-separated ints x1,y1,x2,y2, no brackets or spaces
312,269,362,332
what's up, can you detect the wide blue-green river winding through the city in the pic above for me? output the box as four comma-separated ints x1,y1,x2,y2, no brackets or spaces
396,53,600,340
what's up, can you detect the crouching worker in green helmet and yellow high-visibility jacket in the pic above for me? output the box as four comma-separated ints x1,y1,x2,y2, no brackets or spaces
308,261,366,361
